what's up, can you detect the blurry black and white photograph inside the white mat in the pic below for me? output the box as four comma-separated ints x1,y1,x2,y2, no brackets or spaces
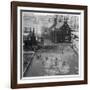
21,10,80,77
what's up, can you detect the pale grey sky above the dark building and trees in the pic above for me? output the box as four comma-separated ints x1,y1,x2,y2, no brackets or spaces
22,12,79,36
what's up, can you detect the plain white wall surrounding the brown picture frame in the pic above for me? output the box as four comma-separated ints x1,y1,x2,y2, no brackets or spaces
0,0,90,90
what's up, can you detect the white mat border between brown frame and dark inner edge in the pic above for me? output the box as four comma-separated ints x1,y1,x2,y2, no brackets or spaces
17,7,84,84
